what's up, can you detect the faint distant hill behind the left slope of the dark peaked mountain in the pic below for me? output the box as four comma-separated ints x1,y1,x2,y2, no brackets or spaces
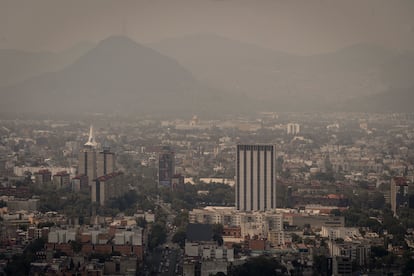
0,42,94,86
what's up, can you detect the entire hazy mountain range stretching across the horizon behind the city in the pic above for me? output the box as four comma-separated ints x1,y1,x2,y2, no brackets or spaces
0,34,414,114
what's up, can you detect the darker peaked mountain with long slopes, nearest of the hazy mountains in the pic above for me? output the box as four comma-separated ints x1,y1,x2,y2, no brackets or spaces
0,37,244,114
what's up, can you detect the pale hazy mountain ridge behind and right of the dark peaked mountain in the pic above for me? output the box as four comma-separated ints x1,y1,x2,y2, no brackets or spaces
150,34,402,111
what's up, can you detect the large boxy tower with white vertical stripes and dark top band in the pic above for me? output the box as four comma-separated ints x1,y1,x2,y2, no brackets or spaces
236,145,276,211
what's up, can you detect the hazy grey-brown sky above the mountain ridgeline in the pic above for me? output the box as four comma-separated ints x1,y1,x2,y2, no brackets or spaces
0,0,414,54
